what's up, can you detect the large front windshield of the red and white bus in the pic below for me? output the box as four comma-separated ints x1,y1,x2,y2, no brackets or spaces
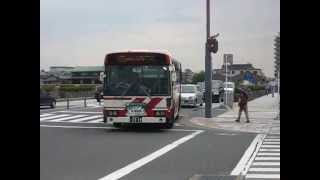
104,65,170,96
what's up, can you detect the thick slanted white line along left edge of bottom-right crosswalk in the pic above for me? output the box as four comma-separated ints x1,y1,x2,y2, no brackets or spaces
231,134,266,176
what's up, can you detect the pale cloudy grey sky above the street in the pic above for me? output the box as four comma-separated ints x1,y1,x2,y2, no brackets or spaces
40,0,280,77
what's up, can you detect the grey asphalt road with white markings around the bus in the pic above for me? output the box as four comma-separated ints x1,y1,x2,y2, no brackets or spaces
40,102,264,180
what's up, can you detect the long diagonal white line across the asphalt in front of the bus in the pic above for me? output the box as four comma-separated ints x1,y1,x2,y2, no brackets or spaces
99,130,203,180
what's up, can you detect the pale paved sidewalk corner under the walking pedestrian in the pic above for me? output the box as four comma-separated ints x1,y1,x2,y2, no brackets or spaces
191,94,280,134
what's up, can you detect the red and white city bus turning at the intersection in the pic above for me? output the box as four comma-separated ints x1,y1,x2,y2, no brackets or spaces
103,50,182,128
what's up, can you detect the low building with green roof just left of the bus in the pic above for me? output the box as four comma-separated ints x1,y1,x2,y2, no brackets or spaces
71,66,104,84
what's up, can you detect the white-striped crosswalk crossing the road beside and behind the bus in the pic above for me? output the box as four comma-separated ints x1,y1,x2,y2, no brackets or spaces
40,111,183,126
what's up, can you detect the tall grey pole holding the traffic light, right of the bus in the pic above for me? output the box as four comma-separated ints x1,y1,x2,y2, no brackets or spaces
205,0,212,118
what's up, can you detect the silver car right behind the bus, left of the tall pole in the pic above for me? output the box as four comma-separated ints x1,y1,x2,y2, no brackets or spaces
181,84,203,107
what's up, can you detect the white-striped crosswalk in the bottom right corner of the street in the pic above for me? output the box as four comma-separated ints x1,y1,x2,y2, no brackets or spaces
246,135,280,180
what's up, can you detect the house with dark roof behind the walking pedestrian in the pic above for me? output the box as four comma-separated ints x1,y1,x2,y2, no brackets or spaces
212,63,266,85
